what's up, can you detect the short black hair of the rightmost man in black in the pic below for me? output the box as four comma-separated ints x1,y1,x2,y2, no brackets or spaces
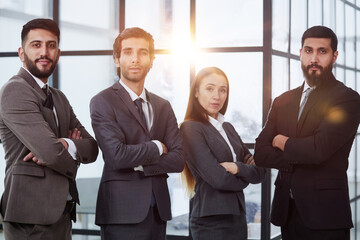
301,26,338,52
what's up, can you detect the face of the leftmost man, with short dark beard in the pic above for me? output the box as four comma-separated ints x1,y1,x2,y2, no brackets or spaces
18,28,60,83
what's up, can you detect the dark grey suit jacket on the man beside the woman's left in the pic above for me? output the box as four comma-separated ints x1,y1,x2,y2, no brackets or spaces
90,82,184,225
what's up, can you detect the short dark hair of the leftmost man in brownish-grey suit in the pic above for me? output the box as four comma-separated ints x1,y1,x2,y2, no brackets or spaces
21,18,60,45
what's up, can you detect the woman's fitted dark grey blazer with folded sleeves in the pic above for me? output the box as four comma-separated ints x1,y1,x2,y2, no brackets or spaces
180,121,265,217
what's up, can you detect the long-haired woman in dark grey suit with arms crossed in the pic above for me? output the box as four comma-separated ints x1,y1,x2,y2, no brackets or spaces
180,67,265,240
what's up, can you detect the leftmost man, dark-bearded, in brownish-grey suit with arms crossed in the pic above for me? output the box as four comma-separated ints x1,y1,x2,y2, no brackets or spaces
0,19,98,240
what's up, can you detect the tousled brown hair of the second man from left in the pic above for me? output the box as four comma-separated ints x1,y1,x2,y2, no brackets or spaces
113,27,155,77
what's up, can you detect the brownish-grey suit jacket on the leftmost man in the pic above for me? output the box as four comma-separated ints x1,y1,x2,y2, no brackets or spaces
0,68,98,224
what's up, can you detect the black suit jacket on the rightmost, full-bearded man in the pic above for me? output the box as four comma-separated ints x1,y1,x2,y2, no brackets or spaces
255,76,360,229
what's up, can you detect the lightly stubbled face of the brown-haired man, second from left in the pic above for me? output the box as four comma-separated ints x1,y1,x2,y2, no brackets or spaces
115,38,153,82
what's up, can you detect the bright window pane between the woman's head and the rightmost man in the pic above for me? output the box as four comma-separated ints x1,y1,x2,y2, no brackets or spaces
196,53,263,143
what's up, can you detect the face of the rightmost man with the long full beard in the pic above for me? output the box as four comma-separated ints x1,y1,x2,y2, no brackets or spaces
300,38,338,86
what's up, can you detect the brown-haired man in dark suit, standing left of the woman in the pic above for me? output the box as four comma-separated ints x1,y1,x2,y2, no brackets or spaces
90,28,184,240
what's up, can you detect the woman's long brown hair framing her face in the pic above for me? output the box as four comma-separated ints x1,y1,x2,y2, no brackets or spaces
184,67,230,123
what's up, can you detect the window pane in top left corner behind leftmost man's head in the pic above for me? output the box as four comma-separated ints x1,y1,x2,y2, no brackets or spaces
0,0,50,52
